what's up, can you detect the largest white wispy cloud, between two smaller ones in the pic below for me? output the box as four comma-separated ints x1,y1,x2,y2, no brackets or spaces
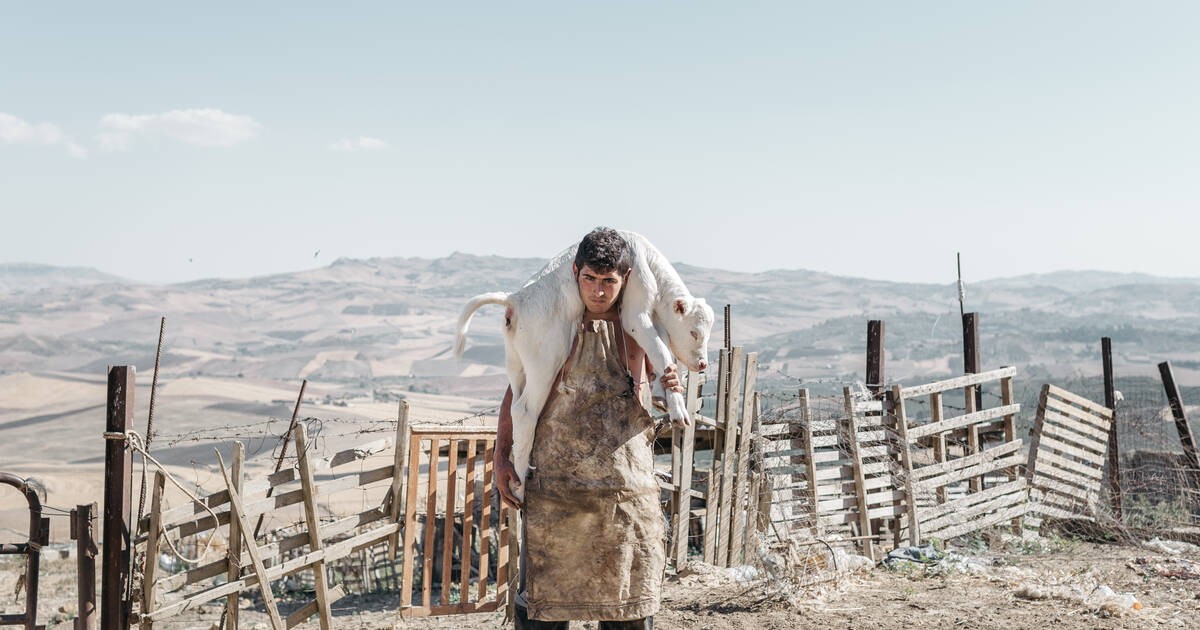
96,109,263,151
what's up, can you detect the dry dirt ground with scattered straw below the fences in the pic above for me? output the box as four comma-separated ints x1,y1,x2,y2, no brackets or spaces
0,542,1200,630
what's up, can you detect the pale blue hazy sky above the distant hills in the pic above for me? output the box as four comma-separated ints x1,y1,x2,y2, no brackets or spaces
0,1,1200,282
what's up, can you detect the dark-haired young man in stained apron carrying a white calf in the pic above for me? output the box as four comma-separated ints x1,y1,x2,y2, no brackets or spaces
494,228,683,630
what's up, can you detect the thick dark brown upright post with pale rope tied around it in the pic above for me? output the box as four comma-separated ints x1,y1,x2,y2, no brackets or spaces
100,365,134,629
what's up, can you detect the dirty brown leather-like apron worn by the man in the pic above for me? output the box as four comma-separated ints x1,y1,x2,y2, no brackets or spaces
522,320,666,622
